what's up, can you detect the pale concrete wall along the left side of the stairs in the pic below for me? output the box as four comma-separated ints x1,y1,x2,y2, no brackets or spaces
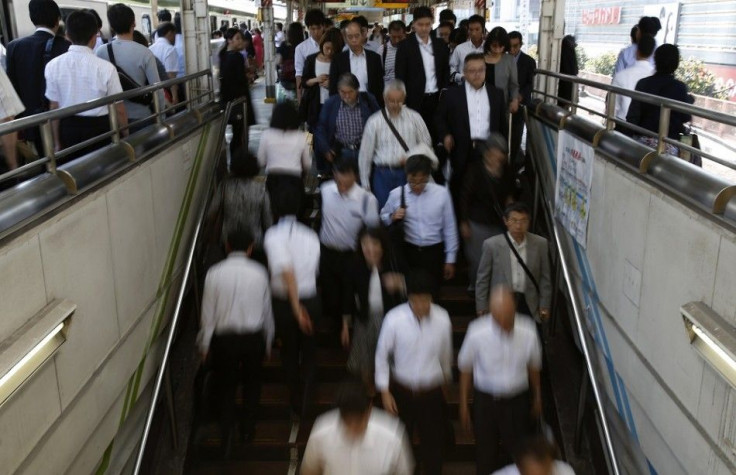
0,126,218,474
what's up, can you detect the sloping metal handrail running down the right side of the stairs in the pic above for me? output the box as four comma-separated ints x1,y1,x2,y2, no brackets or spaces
533,145,621,475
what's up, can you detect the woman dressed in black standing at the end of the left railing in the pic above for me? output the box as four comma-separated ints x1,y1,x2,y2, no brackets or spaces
219,28,256,152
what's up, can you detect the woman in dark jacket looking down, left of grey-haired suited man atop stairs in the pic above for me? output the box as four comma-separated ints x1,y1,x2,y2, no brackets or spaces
299,28,345,132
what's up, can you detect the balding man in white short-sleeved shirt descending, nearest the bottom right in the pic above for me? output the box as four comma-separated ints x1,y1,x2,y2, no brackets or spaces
457,286,542,475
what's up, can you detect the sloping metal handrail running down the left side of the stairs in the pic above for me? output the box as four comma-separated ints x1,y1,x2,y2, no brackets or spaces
133,97,246,475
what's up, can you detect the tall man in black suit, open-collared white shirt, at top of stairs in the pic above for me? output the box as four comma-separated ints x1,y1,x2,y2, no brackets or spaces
396,7,450,149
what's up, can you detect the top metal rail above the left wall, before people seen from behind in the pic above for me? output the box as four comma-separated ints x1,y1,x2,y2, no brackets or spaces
0,70,211,135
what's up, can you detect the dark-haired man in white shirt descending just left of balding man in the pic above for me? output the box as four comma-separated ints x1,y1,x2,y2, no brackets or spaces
375,272,452,475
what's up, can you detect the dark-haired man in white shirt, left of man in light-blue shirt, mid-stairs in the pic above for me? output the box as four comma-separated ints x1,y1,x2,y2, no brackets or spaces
319,157,380,329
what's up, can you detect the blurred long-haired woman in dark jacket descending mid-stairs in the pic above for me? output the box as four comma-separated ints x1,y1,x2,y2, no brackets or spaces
340,228,405,388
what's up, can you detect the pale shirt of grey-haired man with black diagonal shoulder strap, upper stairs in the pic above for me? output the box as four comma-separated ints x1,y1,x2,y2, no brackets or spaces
358,106,432,187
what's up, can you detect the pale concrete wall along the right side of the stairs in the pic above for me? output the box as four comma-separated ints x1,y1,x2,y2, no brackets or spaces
532,118,736,475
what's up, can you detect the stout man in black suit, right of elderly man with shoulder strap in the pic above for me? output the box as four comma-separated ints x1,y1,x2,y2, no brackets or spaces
435,53,507,206
